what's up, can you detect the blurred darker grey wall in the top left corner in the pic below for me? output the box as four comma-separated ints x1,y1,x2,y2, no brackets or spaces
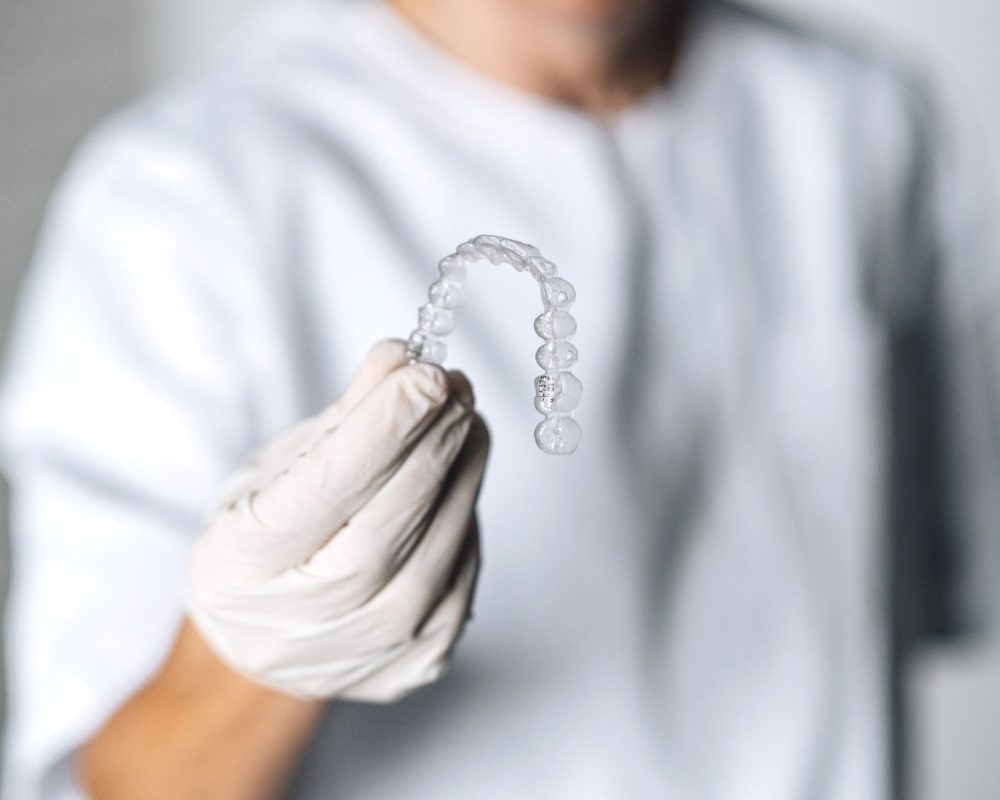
0,0,141,328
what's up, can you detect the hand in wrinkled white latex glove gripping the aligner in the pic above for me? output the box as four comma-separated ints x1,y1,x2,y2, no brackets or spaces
187,341,488,702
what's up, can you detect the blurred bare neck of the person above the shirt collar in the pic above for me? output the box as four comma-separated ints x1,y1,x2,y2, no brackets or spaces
389,0,688,116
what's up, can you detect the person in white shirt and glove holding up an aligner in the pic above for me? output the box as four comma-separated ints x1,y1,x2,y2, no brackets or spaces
0,0,1000,800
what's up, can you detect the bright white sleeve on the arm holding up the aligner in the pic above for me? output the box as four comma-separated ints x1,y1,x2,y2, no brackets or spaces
0,109,266,800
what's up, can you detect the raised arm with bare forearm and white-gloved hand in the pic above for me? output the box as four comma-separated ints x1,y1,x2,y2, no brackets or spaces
82,342,486,800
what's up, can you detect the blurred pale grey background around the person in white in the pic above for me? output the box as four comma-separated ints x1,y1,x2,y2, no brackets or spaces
0,0,1000,800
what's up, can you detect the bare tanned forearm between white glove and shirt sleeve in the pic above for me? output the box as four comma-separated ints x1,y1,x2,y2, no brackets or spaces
81,622,323,800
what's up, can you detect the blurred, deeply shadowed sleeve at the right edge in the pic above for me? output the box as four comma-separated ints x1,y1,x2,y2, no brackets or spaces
887,72,1000,640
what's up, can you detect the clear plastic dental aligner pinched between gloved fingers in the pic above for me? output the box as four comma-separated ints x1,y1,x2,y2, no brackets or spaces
406,235,583,455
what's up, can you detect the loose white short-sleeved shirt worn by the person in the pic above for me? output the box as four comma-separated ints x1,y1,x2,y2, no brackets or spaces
0,0,1000,800
